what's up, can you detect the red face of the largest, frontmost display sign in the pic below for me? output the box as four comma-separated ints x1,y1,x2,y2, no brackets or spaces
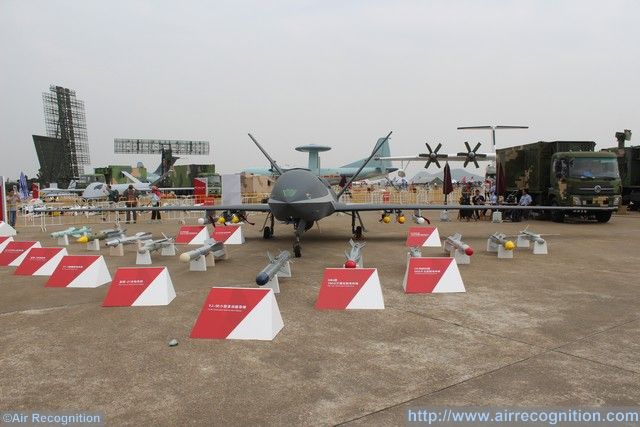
190,288,270,339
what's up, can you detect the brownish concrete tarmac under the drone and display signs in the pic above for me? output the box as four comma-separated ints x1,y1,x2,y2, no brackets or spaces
0,213,640,425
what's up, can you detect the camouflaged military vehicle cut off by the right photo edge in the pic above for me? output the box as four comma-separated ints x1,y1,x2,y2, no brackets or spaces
604,129,640,210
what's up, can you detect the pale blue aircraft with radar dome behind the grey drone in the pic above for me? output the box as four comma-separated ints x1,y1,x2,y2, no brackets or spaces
242,138,398,186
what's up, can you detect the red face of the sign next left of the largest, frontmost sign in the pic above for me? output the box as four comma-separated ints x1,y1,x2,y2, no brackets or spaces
102,267,165,307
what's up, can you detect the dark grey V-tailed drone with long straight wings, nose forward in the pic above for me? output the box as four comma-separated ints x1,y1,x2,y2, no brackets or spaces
34,132,615,257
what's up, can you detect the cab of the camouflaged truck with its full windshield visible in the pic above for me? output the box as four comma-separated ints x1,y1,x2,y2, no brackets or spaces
548,151,622,222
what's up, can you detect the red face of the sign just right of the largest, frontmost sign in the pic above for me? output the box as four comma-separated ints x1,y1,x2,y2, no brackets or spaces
316,268,376,310
